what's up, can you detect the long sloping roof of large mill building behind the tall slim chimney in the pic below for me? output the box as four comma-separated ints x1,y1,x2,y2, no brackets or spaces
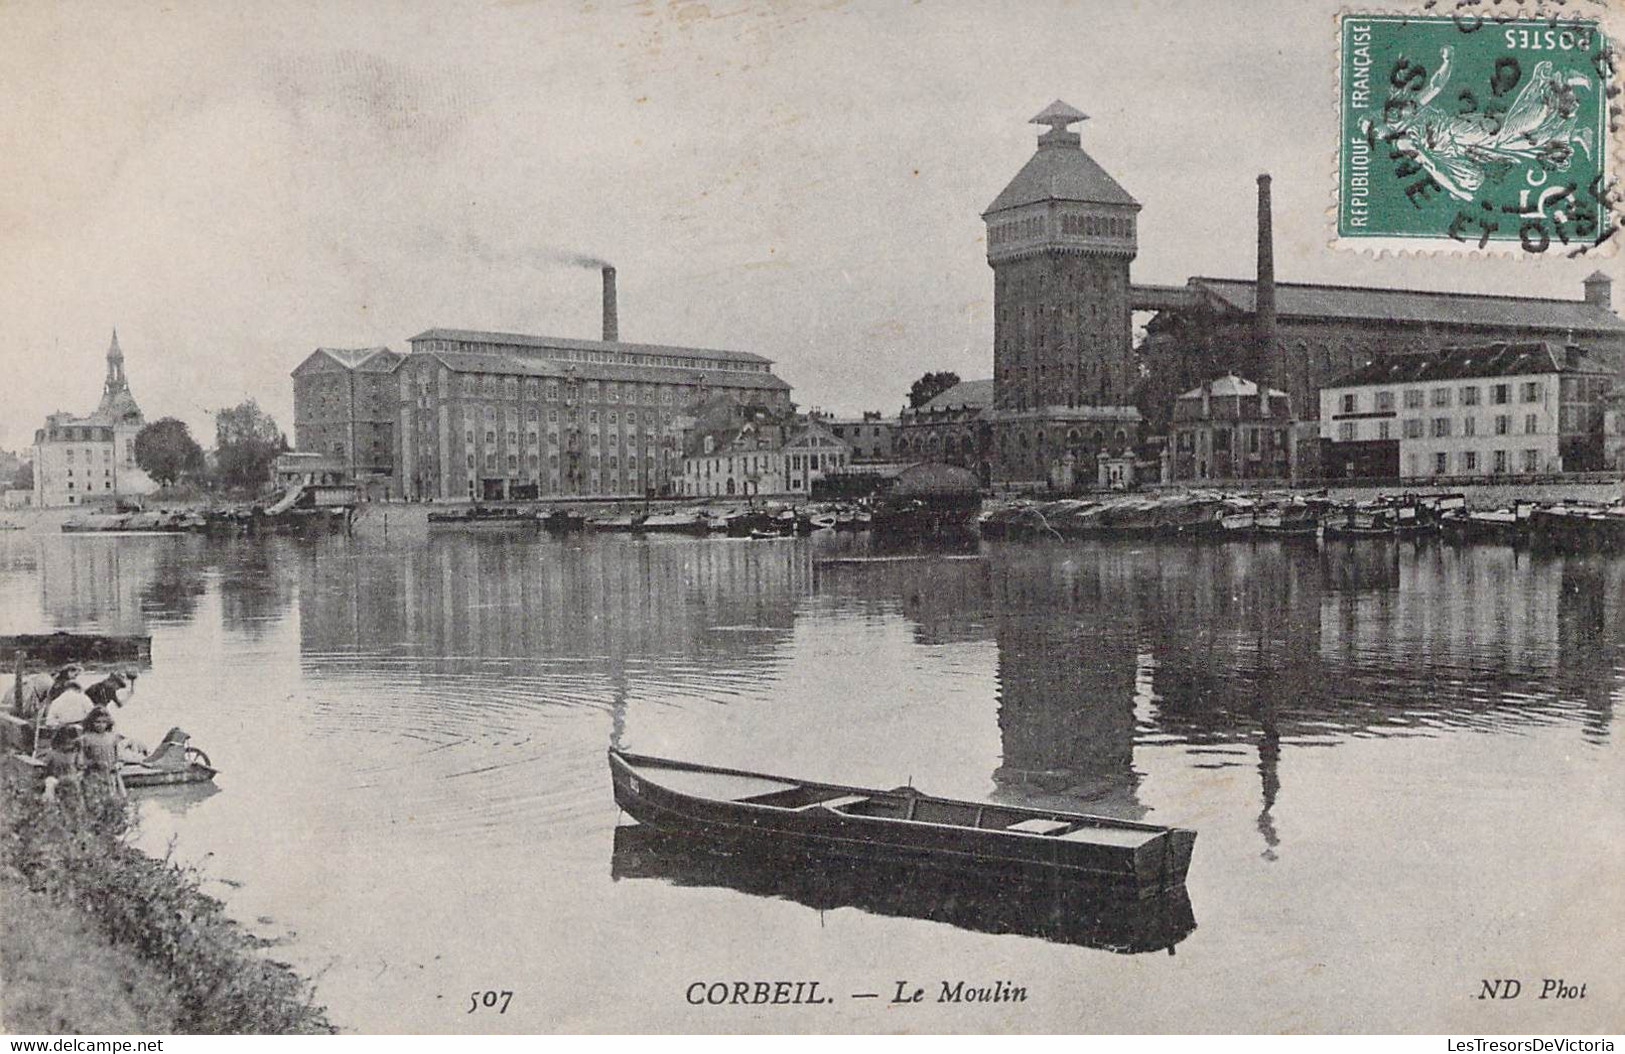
1190,276,1625,333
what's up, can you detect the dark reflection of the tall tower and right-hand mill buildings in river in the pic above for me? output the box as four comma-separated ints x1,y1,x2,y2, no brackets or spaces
817,542,1625,861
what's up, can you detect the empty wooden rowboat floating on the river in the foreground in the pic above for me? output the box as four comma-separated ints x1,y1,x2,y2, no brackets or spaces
609,749,1196,898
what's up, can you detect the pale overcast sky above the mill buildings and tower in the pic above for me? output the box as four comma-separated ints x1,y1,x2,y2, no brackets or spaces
0,0,1625,448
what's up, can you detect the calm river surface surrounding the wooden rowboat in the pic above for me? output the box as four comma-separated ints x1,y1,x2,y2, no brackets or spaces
0,534,1625,1033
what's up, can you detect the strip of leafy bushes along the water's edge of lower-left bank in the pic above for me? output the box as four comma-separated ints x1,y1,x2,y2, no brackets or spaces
0,776,335,1035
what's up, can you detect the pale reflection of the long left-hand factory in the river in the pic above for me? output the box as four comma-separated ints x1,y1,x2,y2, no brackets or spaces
299,534,811,664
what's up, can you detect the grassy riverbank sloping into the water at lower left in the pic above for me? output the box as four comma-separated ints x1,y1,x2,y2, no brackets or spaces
0,778,333,1035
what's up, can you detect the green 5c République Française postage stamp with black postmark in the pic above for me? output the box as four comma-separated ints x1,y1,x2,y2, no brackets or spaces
1337,15,1617,253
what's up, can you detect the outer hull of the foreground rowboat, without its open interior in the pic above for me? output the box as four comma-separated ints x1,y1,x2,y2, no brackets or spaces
609,750,1196,898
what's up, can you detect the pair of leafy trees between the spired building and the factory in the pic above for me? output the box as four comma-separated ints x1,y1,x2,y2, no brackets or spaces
133,400,289,490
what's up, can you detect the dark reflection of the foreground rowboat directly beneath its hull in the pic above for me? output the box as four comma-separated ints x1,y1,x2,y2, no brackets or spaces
609,823,1196,955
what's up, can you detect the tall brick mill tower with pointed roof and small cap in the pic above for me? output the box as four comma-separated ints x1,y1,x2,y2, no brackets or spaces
982,99,1139,486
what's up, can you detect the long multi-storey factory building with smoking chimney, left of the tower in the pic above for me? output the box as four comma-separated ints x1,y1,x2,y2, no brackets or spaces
397,268,790,500
